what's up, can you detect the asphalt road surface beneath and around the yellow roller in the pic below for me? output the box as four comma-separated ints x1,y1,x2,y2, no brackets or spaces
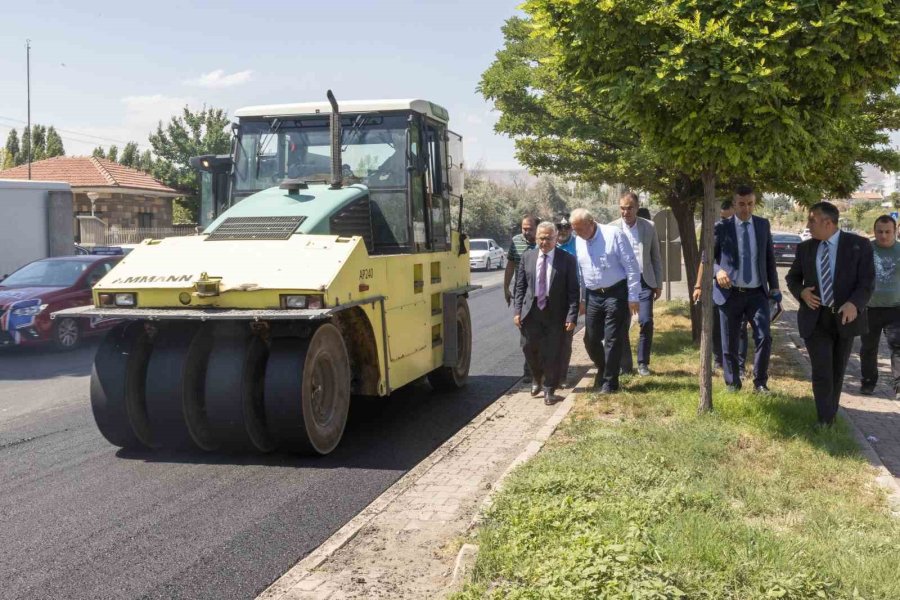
0,272,523,600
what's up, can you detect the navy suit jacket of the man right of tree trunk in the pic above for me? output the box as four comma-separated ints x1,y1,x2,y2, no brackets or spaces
712,215,779,305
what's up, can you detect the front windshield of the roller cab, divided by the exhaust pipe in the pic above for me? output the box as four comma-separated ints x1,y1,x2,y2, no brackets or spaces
234,115,407,193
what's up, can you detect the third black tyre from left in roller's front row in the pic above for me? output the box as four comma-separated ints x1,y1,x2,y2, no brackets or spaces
204,321,275,452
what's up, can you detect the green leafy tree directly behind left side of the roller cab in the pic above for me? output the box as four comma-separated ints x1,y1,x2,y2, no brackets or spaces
150,106,231,222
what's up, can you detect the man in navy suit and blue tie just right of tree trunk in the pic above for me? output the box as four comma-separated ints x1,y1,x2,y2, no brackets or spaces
713,185,781,394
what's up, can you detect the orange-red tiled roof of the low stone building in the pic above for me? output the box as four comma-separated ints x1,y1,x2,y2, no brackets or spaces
0,156,182,197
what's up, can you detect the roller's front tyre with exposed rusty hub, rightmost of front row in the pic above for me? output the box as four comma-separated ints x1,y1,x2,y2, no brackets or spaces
265,323,351,454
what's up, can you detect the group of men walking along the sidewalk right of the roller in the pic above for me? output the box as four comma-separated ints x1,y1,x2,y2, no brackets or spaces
504,186,900,426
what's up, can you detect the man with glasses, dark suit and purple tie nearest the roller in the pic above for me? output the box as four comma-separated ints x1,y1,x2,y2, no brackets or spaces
513,221,578,405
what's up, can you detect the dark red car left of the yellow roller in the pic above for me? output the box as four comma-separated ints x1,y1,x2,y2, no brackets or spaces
0,255,122,350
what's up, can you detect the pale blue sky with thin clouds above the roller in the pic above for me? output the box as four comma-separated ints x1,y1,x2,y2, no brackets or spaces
0,0,520,169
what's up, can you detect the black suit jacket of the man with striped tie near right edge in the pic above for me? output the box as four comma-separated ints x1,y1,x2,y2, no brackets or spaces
785,231,875,338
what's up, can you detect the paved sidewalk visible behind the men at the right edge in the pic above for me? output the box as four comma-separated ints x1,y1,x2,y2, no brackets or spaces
776,296,900,512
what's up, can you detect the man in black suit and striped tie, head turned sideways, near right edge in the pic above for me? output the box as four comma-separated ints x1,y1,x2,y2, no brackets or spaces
785,202,875,426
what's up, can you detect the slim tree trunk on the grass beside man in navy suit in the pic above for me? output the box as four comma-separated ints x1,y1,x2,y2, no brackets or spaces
697,169,718,414
